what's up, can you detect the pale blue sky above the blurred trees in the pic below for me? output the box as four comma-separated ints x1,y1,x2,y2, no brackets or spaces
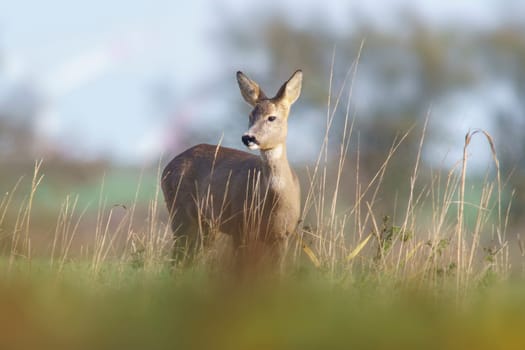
0,0,523,163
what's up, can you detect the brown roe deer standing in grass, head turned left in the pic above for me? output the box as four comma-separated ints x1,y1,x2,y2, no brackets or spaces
161,70,302,261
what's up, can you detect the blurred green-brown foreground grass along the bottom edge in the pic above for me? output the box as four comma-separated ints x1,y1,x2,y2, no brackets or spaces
0,261,525,349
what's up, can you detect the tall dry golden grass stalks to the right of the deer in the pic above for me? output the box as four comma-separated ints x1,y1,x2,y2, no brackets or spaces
288,46,511,293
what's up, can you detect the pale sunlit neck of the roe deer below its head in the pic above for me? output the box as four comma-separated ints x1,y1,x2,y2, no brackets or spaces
261,144,293,193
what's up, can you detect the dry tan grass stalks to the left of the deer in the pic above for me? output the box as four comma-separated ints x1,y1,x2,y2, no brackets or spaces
0,161,173,276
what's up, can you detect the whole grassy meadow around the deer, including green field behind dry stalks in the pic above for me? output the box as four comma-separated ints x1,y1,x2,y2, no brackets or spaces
0,65,525,349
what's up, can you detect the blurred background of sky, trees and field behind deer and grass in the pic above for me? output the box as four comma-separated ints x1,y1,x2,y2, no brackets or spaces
0,0,525,252
